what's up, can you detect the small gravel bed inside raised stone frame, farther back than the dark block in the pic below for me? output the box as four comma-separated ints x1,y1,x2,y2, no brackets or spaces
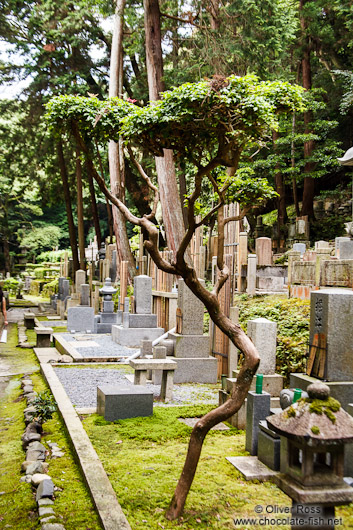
61,333,138,357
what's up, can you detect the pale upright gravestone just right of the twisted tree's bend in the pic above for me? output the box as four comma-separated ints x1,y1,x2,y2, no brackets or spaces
248,318,277,375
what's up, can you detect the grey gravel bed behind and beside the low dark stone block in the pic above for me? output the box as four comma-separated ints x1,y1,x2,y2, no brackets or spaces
54,366,218,407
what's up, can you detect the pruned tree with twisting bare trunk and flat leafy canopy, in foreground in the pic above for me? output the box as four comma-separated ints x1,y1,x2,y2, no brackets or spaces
48,76,303,519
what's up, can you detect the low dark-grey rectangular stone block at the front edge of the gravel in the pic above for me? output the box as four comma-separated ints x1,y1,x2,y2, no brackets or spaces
97,385,153,421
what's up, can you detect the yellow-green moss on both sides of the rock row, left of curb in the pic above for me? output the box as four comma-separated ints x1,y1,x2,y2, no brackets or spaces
0,325,101,530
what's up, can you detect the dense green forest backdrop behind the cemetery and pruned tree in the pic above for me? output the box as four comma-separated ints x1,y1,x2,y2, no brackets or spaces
0,0,353,272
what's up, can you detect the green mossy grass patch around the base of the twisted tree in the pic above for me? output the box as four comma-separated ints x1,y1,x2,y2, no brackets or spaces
83,406,291,530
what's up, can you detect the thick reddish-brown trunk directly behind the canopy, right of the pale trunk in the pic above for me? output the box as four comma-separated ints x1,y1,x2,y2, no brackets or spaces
143,0,184,253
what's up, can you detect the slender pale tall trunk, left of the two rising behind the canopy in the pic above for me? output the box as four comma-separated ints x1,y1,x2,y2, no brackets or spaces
109,0,136,278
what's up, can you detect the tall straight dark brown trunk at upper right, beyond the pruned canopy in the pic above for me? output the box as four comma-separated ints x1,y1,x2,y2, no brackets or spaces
299,0,315,218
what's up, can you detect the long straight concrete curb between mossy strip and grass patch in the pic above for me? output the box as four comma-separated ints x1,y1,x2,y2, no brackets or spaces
40,364,131,530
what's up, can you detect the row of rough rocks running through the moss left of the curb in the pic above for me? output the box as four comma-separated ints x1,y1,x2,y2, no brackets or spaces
21,376,65,530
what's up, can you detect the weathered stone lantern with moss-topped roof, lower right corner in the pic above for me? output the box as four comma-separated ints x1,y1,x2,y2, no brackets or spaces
266,383,353,530
